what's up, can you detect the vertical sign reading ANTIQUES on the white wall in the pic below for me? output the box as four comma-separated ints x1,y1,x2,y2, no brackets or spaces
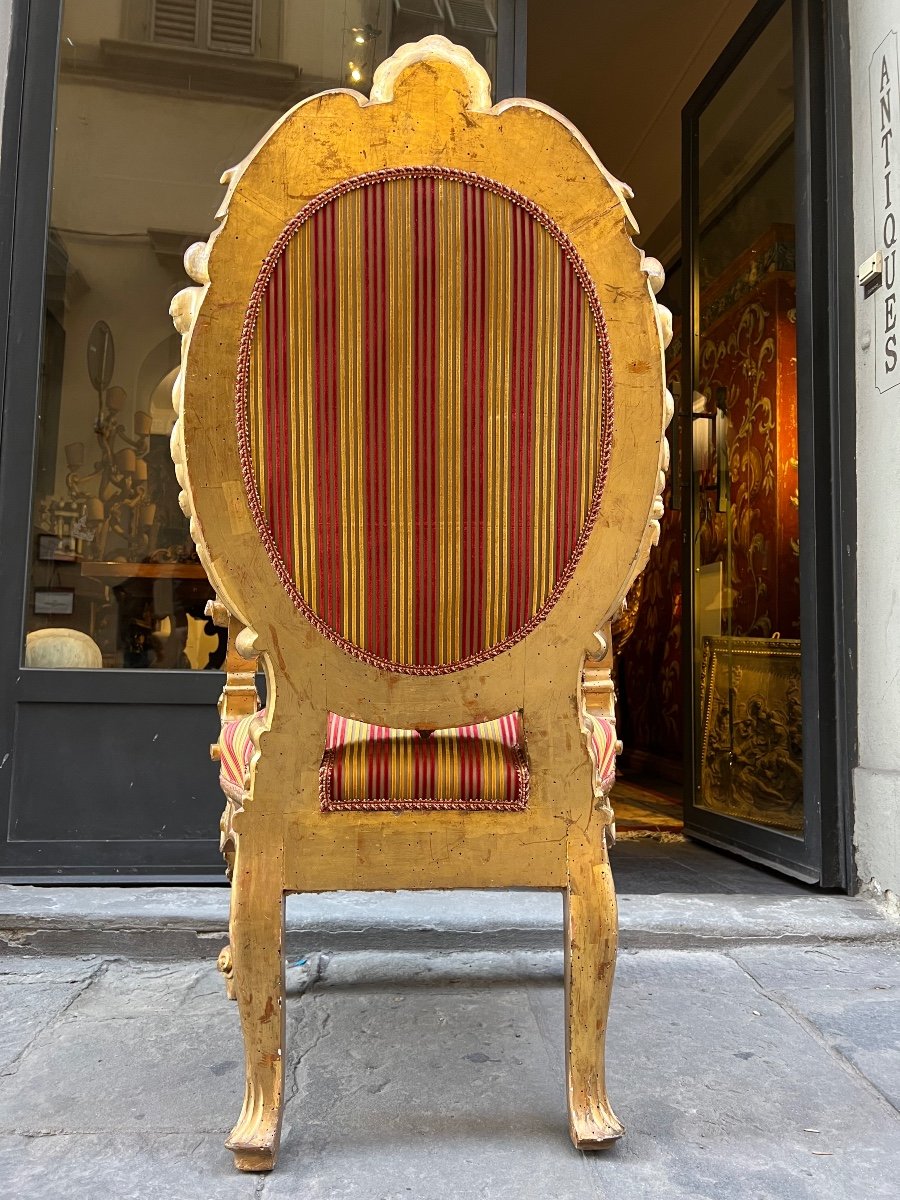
869,30,900,391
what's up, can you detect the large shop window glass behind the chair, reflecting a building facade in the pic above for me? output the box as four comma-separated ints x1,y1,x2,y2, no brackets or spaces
25,0,497,670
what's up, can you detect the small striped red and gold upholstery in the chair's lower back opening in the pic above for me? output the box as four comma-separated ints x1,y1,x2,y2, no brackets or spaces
319,713,528,812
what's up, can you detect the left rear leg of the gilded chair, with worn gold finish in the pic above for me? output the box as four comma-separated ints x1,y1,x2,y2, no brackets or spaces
226,840,284,1171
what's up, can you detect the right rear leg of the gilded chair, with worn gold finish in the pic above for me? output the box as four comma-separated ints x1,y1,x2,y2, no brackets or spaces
564,822,625,1150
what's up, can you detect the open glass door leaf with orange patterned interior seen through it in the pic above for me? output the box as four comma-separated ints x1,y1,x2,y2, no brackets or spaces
679,2,818,880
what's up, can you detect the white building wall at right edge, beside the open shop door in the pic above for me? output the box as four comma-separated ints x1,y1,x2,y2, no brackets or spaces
846,0,900,896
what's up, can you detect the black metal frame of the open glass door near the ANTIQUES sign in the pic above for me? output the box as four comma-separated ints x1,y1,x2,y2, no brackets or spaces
676,0,857,889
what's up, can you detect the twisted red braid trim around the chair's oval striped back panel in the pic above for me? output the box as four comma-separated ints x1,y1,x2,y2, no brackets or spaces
235,167,614,676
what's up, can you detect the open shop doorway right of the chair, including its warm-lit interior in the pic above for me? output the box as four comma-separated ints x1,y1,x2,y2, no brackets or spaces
528,0,846,883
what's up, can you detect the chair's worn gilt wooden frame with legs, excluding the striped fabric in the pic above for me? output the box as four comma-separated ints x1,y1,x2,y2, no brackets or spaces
172,37,672,1170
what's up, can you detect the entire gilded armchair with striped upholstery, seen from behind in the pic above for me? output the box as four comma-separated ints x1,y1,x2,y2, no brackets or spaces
172,37,671,1170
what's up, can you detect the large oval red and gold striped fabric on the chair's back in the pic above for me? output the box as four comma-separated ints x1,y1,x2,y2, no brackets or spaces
236,168,612,673
